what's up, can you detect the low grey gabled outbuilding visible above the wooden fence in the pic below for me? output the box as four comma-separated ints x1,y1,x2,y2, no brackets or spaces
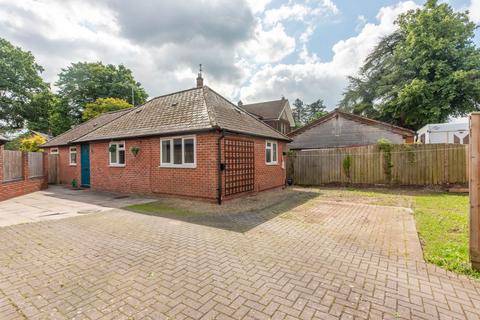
288,110,415,150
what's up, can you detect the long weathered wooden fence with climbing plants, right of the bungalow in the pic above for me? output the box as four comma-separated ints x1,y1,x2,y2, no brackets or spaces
287,144,468,185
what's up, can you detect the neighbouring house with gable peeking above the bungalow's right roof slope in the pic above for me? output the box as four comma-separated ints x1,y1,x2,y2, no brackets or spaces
238,97,295,134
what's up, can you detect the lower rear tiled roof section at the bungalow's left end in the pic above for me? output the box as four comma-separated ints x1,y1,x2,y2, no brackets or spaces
43,109,130,147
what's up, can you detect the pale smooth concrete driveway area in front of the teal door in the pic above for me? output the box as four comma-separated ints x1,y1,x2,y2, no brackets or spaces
0,186,152,227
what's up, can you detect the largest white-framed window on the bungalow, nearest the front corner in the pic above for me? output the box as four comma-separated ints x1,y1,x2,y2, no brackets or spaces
160,136,197,168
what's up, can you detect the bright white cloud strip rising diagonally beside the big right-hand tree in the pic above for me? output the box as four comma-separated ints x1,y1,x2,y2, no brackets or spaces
240,1,418,107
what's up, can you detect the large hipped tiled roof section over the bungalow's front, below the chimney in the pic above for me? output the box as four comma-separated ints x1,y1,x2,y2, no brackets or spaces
76,86,290,142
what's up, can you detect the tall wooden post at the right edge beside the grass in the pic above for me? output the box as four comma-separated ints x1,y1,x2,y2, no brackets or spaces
469,112,480,270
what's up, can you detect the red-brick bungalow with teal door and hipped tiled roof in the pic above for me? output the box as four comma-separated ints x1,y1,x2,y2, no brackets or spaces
44,75,290,203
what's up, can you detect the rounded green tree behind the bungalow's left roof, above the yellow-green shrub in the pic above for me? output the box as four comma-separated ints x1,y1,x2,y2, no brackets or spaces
56,62,148,124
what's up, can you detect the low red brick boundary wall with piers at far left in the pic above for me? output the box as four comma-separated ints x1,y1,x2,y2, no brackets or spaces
0,146,48,201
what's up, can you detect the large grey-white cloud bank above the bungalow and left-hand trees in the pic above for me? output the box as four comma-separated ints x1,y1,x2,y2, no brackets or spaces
0,0,258,96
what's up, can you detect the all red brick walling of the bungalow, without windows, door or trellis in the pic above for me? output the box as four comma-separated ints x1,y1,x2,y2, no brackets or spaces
54,133,285,201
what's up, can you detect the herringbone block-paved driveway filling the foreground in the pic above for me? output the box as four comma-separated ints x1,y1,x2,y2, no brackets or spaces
0,189,480,319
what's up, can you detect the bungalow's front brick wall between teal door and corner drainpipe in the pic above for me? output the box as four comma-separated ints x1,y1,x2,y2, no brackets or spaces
90,134,217,199
